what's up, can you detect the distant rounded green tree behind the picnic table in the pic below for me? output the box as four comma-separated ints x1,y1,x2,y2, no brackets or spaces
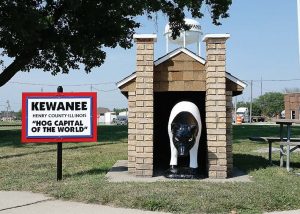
254,92,284,117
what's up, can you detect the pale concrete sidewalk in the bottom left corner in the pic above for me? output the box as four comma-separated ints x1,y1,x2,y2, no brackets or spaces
0,191,169,214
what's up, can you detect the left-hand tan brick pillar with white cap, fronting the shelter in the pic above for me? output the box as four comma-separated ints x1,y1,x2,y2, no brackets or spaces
133,34,156,177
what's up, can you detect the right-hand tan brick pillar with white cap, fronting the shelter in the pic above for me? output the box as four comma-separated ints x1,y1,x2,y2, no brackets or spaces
203,34,232,178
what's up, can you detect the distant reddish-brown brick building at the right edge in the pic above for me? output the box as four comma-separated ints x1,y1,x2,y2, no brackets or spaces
284,93,300,120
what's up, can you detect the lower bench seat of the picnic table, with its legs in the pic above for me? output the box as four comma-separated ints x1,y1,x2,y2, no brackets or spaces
249,137,300,169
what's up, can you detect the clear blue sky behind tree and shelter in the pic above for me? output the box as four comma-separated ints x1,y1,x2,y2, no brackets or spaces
0,0,300,111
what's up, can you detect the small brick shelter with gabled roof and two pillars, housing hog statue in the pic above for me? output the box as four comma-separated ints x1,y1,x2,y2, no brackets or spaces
117,34,246,178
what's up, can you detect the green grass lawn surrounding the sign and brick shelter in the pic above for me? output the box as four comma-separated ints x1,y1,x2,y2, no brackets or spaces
0,125,300,213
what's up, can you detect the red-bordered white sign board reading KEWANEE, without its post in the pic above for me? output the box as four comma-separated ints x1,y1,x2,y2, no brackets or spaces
22,92,97,143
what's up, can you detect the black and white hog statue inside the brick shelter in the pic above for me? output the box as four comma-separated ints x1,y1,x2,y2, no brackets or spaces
165,101,202,179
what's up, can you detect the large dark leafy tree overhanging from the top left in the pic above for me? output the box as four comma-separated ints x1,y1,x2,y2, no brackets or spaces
0,0,232,87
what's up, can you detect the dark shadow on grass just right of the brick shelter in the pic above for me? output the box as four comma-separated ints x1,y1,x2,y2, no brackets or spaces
233,154,270,173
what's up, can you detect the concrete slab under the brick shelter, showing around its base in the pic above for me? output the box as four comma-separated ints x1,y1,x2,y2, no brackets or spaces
105,160,251,183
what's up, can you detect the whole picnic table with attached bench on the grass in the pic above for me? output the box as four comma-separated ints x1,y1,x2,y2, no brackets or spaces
249,119,300,171
